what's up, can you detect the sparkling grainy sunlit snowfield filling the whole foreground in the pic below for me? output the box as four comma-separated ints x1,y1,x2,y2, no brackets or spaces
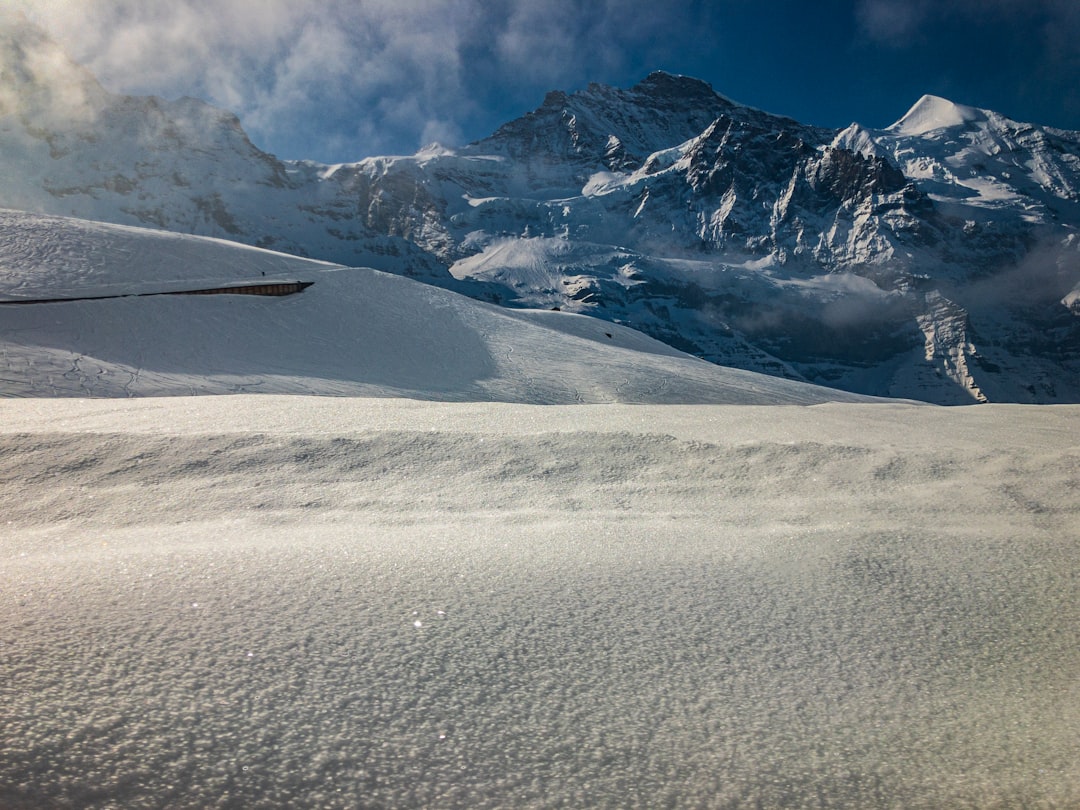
0,396,1080,808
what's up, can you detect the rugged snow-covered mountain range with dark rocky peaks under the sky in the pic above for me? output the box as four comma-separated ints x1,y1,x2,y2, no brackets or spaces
0,11,1080,403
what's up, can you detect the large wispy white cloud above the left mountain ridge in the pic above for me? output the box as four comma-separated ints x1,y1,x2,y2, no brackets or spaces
6,0,708,159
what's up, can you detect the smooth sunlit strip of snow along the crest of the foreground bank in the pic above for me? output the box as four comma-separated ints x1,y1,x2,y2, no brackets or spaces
21,395,1080,450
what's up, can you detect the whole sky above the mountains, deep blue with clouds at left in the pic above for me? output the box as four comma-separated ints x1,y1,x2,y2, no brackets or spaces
14,0,1080,163
